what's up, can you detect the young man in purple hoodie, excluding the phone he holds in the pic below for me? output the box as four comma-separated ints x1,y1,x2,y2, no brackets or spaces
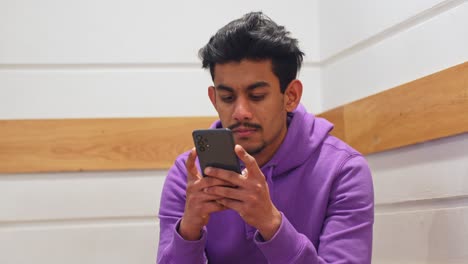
158,12,374,264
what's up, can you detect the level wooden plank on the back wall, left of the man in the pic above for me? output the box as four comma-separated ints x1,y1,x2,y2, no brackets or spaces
0,117,215,173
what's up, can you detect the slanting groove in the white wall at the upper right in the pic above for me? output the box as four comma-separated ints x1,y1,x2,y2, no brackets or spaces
319,0,468,66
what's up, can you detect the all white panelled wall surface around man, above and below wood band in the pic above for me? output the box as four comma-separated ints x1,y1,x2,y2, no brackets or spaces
0,0,468,264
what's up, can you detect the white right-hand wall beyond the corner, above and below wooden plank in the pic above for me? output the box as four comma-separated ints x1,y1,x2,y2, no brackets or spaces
319,0,468,264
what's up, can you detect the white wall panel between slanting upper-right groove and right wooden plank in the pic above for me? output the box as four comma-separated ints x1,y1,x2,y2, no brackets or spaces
322,3,468,109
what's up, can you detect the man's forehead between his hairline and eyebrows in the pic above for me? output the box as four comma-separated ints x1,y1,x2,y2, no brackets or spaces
213,60,279,88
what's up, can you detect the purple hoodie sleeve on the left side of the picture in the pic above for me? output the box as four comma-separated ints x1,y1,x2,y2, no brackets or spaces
157,155,206,264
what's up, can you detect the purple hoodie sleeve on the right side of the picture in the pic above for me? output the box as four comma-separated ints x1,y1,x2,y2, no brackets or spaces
255,155,374,264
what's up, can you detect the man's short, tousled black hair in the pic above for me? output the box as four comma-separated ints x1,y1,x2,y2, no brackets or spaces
198,12,304,93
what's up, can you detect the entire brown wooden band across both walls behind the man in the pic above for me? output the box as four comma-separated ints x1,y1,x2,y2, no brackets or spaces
0,62,468,173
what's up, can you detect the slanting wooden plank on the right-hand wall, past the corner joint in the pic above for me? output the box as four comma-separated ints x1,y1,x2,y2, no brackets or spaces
344,62,468,154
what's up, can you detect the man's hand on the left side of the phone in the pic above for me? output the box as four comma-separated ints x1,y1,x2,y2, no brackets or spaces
178,148,229,240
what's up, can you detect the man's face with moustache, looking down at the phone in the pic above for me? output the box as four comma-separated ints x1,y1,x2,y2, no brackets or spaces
209,60,287,162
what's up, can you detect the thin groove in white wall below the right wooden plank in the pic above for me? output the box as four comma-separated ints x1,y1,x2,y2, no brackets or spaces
375,195,468,215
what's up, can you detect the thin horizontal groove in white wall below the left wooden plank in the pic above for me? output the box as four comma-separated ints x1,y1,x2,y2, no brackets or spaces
0,215,159,231
